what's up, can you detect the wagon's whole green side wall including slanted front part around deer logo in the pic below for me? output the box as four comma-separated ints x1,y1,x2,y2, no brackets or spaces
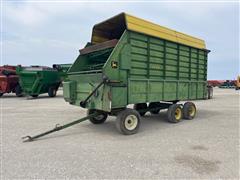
103,31,207,108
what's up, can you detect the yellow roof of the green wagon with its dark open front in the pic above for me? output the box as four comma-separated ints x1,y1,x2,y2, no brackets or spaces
91,13,206,49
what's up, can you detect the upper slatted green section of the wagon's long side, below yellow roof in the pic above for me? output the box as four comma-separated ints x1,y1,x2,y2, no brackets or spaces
129,32,207,81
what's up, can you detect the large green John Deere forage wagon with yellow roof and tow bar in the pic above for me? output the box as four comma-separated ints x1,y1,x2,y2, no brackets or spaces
22,13,209,141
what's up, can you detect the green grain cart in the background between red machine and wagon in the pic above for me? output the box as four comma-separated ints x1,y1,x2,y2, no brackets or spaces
17,64,71,97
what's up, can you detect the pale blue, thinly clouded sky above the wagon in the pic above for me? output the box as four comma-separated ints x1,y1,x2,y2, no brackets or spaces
1,0,240,79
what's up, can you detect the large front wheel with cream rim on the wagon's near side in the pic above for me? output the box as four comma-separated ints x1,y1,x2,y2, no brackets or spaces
116,108,141,135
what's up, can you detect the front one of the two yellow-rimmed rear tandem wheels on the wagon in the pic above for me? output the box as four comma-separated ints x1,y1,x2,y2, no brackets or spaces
167,104,183,123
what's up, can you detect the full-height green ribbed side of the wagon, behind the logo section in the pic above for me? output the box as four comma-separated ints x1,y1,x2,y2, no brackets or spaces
128,32,207,103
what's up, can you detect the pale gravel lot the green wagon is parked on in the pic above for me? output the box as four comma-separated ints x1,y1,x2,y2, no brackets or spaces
0,88,240,179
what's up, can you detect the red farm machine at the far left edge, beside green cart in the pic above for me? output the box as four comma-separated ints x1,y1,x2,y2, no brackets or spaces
0,65,22,97
